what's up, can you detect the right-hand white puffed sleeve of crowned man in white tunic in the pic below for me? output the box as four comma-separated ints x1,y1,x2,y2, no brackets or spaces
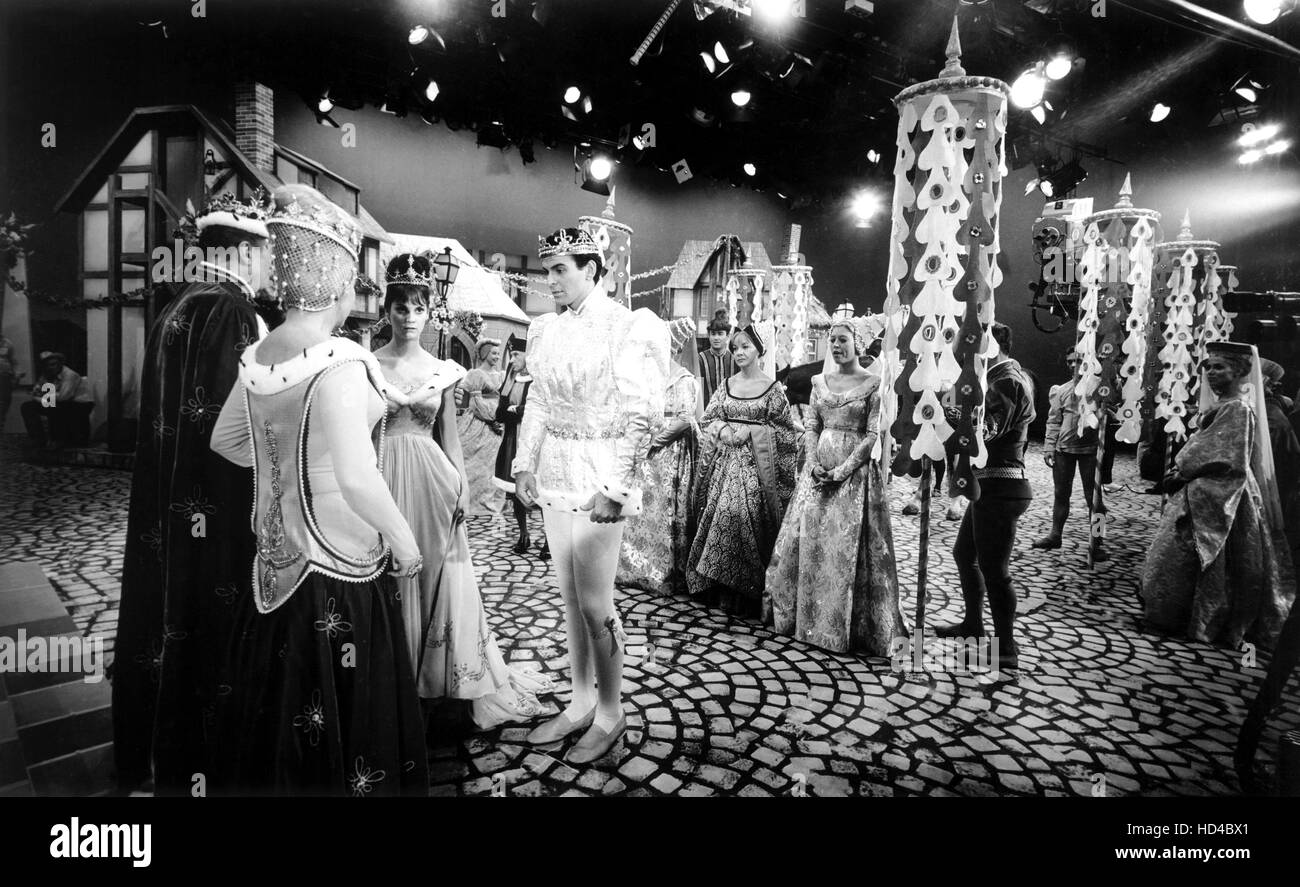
601,308,670,505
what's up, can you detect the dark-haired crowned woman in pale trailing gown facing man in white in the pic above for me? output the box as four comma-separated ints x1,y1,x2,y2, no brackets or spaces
374,254,550,730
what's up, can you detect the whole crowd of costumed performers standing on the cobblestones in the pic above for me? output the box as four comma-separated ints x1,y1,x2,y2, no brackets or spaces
113,185,1300,795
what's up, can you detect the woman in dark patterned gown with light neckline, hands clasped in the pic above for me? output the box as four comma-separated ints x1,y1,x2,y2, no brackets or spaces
686,326,798,615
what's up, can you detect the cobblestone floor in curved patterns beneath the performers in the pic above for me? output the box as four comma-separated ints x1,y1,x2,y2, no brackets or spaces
0,438,1300,796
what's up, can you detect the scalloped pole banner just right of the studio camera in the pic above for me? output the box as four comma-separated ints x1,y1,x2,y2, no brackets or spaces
1074,176,1160,444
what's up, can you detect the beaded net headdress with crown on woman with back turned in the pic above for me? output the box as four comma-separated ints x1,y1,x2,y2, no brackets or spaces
267,185,361,311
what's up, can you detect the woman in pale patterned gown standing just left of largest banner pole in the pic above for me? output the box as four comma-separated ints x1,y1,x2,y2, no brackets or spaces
763,321,907,657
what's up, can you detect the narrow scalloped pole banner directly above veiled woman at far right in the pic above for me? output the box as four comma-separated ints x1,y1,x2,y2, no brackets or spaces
1154,213,1222,439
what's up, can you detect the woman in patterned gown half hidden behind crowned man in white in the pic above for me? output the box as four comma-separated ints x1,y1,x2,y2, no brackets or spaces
615,317,703,594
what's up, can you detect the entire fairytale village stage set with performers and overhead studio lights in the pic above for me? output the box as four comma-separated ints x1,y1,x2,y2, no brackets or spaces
0,0,1300,797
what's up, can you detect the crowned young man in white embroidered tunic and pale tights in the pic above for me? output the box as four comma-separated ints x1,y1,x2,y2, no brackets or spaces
512,228,668,763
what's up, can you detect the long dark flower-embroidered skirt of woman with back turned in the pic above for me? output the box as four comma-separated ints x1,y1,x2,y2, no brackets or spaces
217,574,429,797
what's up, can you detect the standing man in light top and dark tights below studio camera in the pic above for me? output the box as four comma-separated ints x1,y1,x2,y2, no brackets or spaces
1034,351,1109,562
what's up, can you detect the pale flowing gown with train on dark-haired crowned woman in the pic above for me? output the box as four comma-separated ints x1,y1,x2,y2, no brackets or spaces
381,360,550,730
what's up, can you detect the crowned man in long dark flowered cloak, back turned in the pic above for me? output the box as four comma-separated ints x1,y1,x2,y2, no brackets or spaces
112,189,274,795
